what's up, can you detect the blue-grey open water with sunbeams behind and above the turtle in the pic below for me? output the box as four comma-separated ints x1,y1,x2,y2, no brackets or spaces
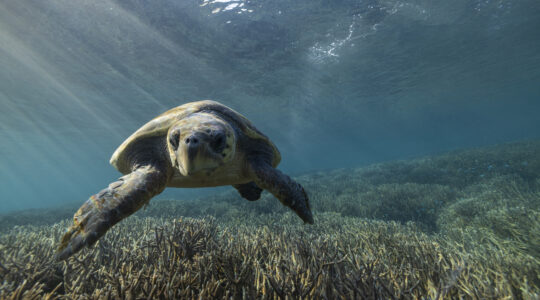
0,0,540,212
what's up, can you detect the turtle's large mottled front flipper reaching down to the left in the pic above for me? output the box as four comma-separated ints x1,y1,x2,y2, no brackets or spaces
56,165,167,260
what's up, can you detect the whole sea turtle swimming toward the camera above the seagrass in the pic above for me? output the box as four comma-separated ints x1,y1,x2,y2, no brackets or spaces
57,100,313,260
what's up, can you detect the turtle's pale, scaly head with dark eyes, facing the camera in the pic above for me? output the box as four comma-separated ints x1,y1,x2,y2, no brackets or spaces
167,113,236,176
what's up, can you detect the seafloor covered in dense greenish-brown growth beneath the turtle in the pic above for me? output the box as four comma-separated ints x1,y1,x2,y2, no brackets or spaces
0,141,540,299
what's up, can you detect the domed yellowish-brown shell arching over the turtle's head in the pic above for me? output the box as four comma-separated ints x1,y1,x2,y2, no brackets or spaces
110,100,281,174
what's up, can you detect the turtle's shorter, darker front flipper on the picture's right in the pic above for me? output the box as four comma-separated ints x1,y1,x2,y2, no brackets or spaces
251,161,313,224
